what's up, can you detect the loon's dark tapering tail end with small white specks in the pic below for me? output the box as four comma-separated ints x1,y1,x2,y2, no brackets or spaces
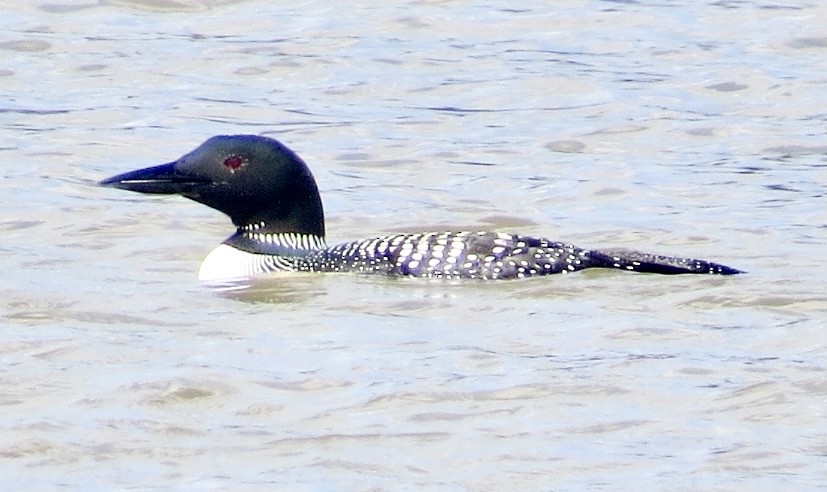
589,249,744,275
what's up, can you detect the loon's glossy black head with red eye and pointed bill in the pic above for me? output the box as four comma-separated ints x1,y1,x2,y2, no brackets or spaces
100,135,324,237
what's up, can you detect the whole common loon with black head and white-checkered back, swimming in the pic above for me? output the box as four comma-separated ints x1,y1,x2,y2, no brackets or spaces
100,135,741,281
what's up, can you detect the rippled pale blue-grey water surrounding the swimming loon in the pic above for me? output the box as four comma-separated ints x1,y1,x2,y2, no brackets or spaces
0,0,827,490
